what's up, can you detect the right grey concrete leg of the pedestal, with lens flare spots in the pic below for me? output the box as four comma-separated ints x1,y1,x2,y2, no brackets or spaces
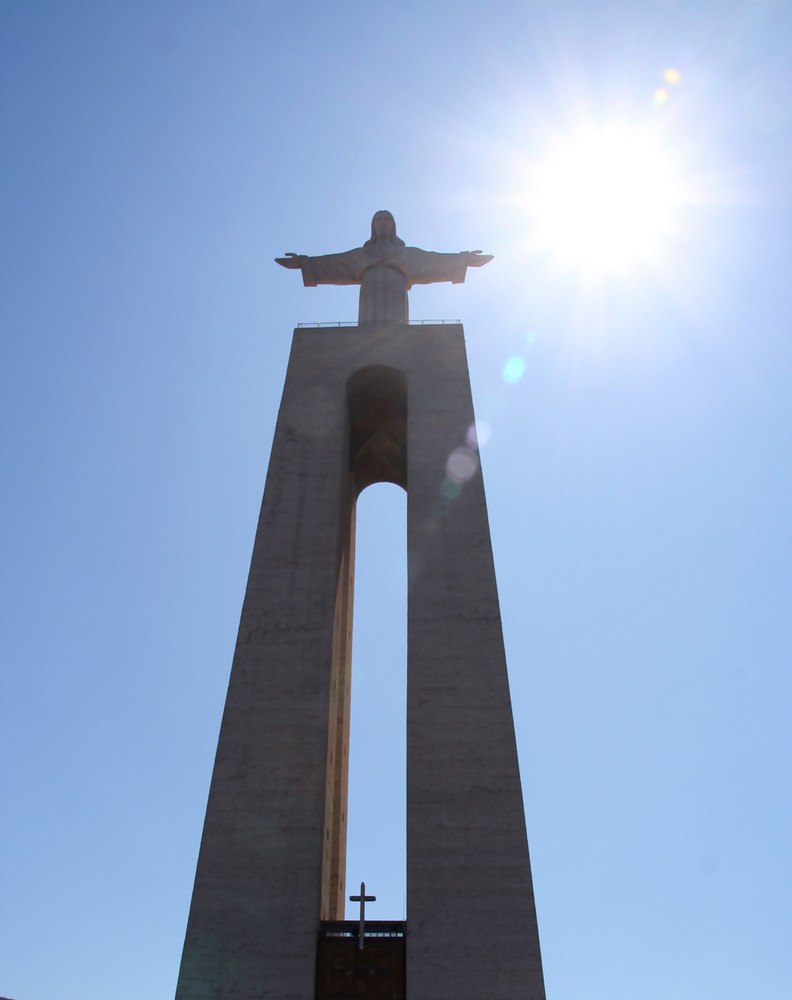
407,327,544,1000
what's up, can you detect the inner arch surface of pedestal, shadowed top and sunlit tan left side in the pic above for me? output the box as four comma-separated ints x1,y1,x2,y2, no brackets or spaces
320,365,407,920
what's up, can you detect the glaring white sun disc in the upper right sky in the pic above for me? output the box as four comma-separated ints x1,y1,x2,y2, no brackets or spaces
529,124,683,280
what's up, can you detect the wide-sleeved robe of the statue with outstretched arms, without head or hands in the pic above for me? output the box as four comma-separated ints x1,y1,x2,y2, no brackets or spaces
298,242,469,323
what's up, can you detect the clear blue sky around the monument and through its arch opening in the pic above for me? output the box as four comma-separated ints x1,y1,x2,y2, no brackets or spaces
0,0,792,1000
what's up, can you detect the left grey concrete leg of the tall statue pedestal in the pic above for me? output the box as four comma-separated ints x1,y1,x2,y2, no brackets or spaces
176,330,351,1000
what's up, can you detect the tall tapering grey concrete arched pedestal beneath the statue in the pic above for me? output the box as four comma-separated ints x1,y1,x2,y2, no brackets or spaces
176,219,545,1000
